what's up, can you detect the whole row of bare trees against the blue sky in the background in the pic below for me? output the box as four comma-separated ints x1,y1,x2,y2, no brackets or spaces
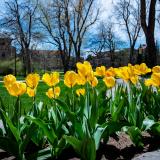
0,0,160,74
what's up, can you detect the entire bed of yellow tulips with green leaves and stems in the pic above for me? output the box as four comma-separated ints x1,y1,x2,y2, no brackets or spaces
0,61,160,160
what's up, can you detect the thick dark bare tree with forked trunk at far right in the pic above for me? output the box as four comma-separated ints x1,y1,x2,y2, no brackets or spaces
140,0,157,67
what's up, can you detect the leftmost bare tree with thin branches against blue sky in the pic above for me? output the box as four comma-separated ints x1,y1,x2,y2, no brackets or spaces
1,0,40,74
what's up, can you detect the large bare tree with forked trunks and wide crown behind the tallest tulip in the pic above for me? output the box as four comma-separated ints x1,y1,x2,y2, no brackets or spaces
40,0,99,71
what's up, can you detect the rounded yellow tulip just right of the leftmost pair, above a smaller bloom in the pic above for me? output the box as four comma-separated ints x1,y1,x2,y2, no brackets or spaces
26,73,40,89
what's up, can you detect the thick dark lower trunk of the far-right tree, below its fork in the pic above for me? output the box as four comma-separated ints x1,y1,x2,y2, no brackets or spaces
145,32,157,68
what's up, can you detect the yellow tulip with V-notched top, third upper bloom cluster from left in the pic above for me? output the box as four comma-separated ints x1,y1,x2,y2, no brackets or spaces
42,72,59,87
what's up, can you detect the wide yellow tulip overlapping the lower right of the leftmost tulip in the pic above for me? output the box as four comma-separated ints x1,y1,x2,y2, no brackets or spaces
7,82,26,97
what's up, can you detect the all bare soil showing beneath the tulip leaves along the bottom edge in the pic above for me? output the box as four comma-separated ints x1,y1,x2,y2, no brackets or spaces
0,132,160,160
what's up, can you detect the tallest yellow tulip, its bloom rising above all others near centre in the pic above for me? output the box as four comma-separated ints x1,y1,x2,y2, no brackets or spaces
76,61,92,78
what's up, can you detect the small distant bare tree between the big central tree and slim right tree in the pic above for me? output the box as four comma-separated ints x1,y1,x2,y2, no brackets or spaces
89,21,124,59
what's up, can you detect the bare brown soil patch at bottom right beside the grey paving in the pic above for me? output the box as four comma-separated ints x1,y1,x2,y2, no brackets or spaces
97,132,160,160
